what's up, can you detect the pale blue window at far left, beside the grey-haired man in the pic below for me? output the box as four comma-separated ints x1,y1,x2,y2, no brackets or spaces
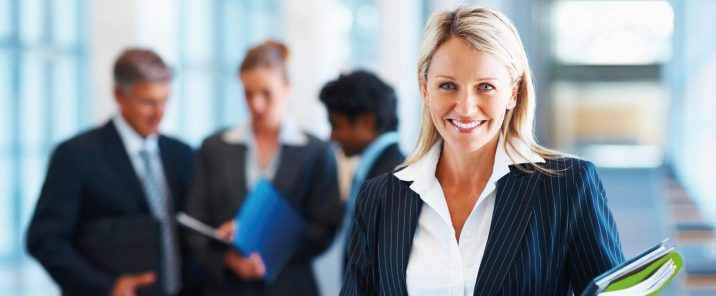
0,0,89,261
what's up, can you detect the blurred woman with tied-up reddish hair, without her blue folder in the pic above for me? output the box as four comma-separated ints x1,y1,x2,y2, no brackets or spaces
187,41,343,295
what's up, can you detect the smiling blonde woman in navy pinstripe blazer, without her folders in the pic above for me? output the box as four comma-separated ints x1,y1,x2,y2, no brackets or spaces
341,6,624,295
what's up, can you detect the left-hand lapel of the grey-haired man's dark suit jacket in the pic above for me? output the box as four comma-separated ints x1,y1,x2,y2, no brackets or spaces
103,121,149,210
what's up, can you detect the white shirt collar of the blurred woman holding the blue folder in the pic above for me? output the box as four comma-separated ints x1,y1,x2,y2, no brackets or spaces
222,118,308,146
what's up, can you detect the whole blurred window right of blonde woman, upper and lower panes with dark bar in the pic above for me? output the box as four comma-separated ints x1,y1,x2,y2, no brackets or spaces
550,0,674,167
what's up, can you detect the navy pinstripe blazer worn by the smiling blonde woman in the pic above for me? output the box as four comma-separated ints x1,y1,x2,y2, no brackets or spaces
341,158,624,295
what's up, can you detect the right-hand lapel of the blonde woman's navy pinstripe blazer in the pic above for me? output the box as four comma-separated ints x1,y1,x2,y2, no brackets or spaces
475,166,541,295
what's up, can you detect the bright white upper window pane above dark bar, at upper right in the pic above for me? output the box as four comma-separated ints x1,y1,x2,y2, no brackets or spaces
553,0,674,65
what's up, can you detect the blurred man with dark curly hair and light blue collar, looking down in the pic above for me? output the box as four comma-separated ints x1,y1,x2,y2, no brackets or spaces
319,70,405,266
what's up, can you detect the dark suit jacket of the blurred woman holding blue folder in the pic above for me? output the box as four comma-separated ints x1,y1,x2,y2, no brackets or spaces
187,131,343,295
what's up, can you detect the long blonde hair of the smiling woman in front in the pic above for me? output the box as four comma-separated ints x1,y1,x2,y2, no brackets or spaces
401,6,563,174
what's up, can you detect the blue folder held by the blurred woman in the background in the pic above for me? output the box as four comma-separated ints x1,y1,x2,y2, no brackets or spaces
233,178,307,283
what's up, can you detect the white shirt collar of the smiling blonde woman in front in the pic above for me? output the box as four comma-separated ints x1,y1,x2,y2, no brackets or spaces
394,136,545,194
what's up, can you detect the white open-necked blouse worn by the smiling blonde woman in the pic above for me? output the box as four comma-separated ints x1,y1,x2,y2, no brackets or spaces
395,138,544,295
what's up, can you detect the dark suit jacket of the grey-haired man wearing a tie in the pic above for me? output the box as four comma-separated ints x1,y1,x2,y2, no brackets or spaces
27,121,194,295
